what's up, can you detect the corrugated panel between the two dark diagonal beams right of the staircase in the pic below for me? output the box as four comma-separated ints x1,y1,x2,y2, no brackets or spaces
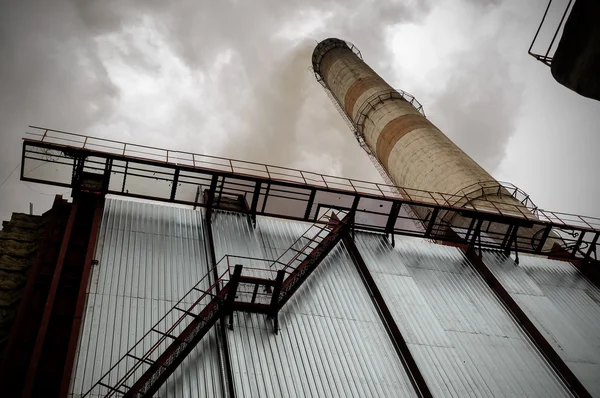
356,234,569,397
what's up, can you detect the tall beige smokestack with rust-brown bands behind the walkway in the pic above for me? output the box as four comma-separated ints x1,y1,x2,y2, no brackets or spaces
312,38,556,249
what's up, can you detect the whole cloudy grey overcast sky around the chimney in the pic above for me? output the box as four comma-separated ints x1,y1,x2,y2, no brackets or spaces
0,0,600,224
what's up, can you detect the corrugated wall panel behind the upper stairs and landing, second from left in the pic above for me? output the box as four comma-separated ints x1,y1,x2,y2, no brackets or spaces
213,213,415,397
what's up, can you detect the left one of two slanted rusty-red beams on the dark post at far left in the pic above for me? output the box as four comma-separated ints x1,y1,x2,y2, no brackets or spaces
23,198,79,397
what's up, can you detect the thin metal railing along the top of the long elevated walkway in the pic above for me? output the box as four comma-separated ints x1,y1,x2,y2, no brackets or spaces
25,126,600,230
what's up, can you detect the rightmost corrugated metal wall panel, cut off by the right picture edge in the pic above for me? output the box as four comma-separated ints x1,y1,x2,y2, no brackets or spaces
484,252,600,397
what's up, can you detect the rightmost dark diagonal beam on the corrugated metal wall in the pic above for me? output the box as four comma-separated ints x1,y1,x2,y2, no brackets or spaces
463,236,591,398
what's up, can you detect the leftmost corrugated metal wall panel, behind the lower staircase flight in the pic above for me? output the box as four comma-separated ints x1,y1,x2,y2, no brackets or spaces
71,199,221,397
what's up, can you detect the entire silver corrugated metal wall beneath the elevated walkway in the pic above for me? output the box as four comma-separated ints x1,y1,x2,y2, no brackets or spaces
71,199,600,397
